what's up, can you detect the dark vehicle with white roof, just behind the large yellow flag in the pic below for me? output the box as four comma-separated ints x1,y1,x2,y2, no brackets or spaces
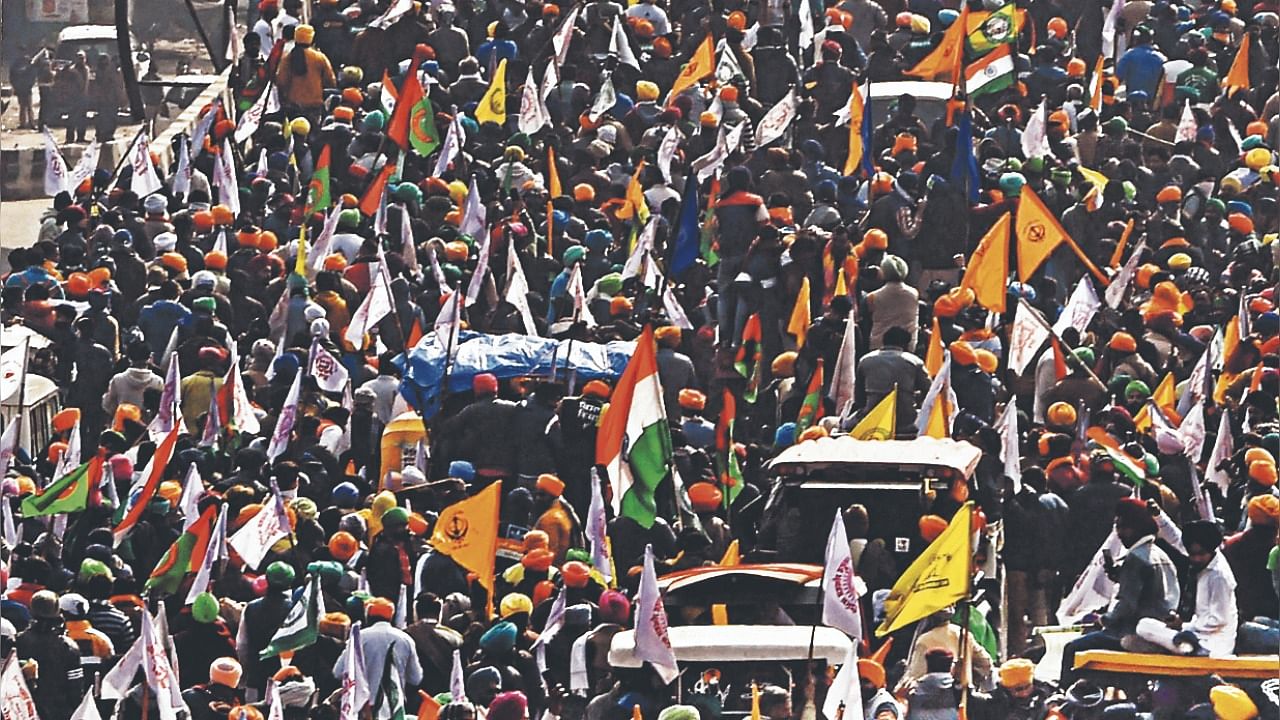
762,435,982,568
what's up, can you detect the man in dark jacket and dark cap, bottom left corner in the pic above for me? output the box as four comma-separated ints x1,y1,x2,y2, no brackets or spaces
14,591,84,720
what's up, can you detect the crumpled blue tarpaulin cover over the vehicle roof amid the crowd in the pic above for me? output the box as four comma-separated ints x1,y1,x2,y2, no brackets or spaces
396,331,635,418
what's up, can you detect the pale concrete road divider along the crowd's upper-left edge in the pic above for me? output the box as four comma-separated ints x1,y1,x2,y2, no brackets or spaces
0,68,230,200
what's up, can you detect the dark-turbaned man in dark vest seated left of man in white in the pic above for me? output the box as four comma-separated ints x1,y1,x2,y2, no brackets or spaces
1060,497,1180,684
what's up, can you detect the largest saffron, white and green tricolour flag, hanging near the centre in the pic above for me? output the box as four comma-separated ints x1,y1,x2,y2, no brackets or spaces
595,327,672,529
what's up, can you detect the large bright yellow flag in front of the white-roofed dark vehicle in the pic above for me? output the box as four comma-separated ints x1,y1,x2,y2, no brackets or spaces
876,502,973,635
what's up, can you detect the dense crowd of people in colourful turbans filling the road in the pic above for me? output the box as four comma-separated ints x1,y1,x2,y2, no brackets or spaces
0,0,1280,720
